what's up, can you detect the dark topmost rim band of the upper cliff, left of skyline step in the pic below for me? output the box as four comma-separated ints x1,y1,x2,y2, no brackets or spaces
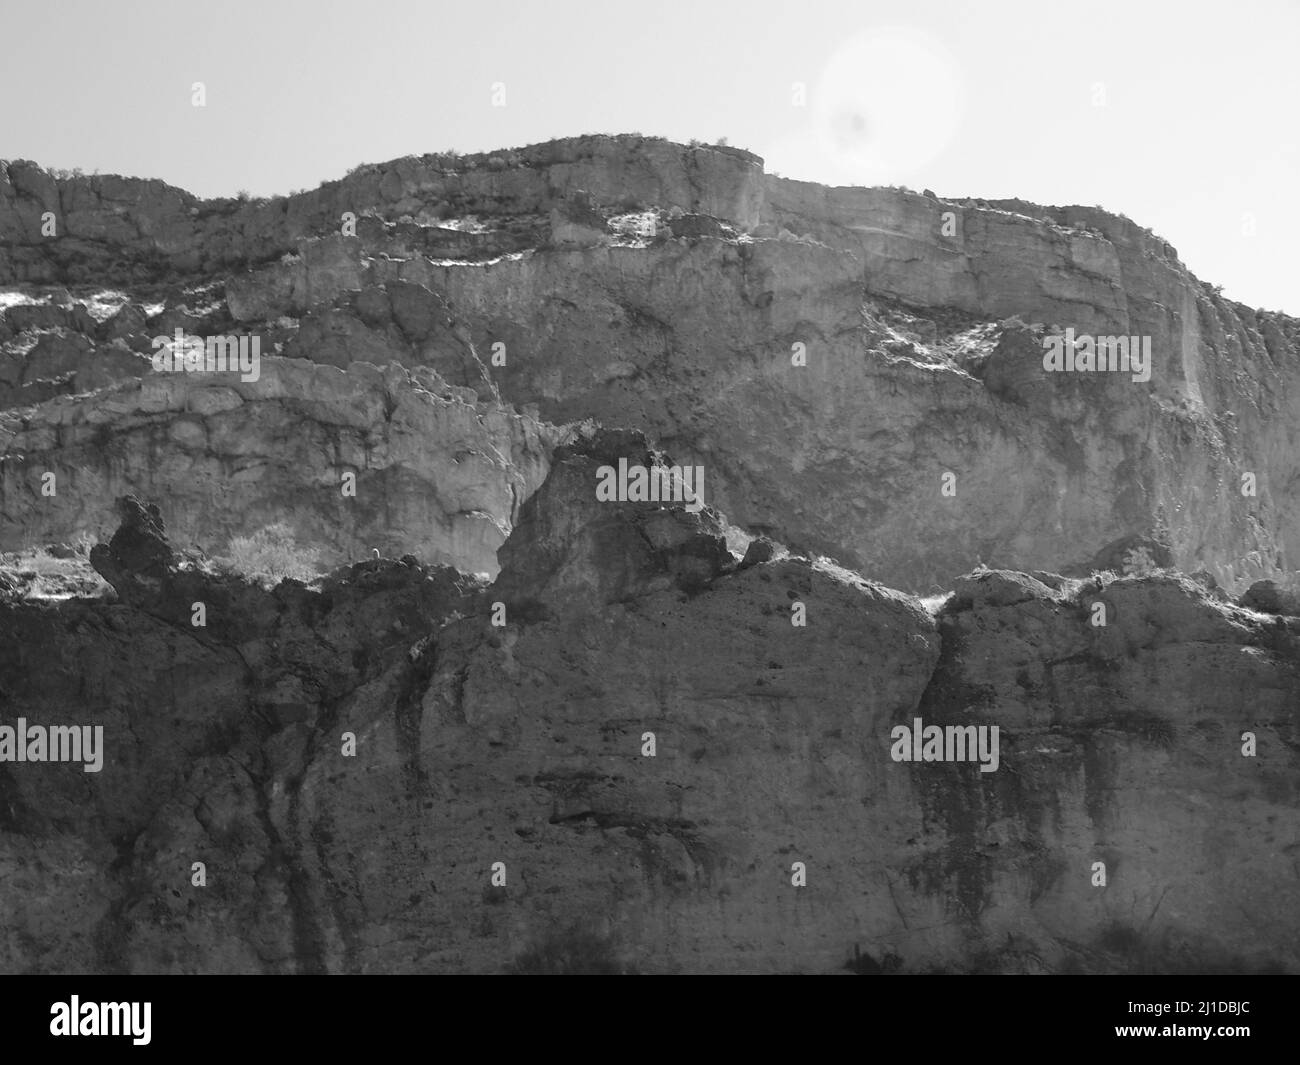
0,137,763,285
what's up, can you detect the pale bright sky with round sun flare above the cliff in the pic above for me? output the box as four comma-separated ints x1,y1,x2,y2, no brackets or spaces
0,0,1300,315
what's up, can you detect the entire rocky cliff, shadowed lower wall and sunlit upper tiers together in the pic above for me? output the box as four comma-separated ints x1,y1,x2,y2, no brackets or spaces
0,137,1300,973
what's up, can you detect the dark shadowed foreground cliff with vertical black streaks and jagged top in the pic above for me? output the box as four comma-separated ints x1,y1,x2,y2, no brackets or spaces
0,434,1300,973
